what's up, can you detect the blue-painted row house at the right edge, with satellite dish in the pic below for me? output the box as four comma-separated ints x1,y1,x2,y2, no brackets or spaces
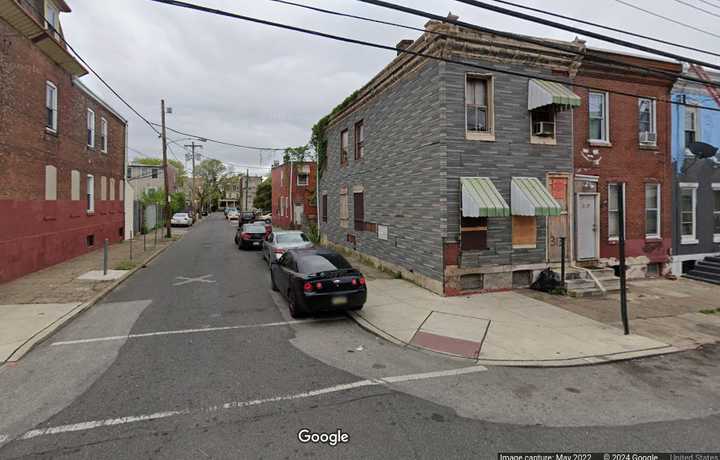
672,66,720,283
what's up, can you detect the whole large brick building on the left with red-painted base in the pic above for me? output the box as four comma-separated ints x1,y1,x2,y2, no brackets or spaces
0,0,127,281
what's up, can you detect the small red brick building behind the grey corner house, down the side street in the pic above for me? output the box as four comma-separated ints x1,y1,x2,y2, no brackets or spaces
272,161,317,228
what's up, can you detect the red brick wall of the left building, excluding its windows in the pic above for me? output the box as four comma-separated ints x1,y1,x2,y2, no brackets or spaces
0,21,126,282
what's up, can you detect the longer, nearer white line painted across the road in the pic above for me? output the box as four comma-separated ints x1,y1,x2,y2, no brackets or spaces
0,366,487,445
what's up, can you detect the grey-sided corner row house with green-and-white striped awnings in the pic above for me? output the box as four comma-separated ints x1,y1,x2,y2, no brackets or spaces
319,21,585,295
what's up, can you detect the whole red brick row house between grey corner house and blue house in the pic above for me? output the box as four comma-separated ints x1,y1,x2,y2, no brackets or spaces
574,49,682,278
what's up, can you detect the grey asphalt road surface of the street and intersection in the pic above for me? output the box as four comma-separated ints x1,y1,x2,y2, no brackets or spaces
0,215,720,459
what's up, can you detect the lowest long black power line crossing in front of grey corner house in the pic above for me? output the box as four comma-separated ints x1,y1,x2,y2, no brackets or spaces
150,0,720,112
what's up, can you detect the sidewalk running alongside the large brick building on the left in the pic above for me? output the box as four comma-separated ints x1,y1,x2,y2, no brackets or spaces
0,229,186,363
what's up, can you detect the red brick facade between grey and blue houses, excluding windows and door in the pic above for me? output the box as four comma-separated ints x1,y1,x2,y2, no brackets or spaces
574,70,672,262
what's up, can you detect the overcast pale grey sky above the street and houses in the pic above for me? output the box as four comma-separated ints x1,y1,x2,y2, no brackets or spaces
61,0,720,173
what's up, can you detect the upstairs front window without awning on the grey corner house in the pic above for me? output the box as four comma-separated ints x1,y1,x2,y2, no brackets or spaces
465,75,493,140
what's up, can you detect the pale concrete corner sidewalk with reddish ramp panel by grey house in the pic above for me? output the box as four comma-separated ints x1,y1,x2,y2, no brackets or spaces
353,278,680,366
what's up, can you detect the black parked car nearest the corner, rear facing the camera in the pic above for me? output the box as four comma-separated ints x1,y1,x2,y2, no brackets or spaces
270,248,367,318
